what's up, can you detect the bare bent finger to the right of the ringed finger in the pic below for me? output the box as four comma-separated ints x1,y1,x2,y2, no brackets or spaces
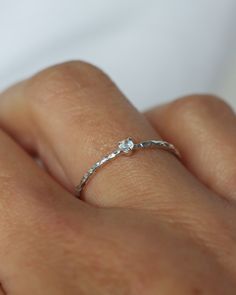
146,95,236,200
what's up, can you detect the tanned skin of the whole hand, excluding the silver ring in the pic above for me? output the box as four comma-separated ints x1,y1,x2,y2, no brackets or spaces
0,62,236,295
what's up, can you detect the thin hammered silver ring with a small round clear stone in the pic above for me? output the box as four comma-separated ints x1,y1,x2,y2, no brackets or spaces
75,137,180,198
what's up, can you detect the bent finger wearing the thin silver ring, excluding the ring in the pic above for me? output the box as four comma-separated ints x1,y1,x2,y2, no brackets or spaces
0,62,214,208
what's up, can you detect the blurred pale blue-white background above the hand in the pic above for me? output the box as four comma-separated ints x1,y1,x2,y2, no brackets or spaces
0,0,236,110
